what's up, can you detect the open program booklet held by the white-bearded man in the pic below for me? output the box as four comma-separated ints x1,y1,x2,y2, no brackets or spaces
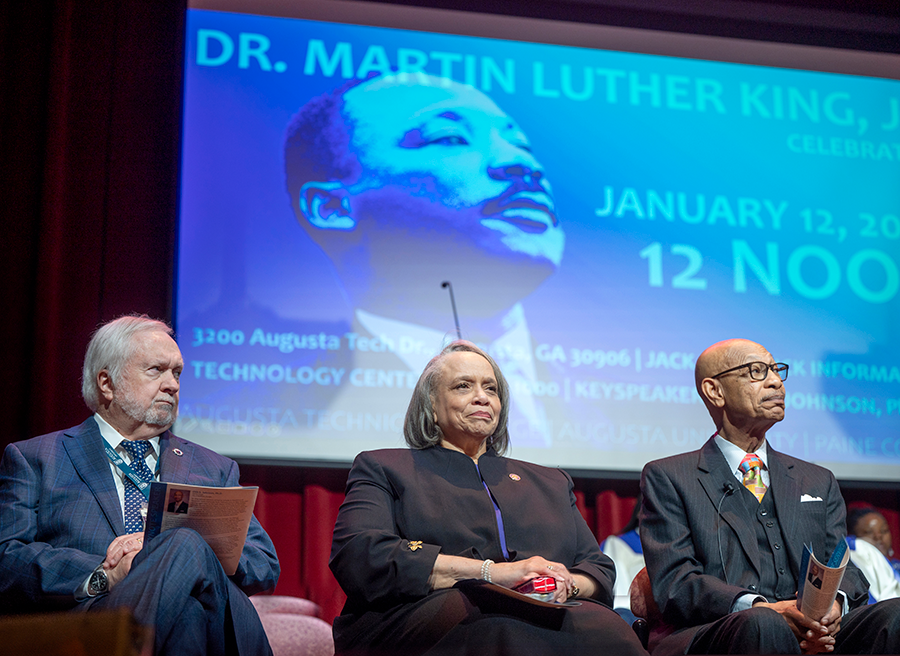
144,483,259,576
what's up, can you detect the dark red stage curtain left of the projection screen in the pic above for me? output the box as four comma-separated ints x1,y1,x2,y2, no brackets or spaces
0,0,185,445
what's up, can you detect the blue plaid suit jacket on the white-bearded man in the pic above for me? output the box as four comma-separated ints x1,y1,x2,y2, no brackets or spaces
0,417,280,612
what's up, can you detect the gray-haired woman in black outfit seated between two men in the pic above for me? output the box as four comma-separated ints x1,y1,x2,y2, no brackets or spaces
330,341,646,656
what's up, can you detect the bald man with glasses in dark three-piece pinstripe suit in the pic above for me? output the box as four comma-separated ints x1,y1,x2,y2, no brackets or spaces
641,340,900,656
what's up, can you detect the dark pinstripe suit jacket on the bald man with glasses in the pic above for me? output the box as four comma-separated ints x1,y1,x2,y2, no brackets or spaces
641,438,900,653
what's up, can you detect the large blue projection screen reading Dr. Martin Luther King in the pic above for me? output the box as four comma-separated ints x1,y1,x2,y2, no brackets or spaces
176,0,900,480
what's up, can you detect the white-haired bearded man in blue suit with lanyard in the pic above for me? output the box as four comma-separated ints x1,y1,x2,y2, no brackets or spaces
0,316,280,656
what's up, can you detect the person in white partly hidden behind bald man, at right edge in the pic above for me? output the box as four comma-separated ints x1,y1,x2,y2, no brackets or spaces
847,506,900,603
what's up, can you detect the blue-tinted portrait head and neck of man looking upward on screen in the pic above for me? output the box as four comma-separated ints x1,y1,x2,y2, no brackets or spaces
285,73,565,354
